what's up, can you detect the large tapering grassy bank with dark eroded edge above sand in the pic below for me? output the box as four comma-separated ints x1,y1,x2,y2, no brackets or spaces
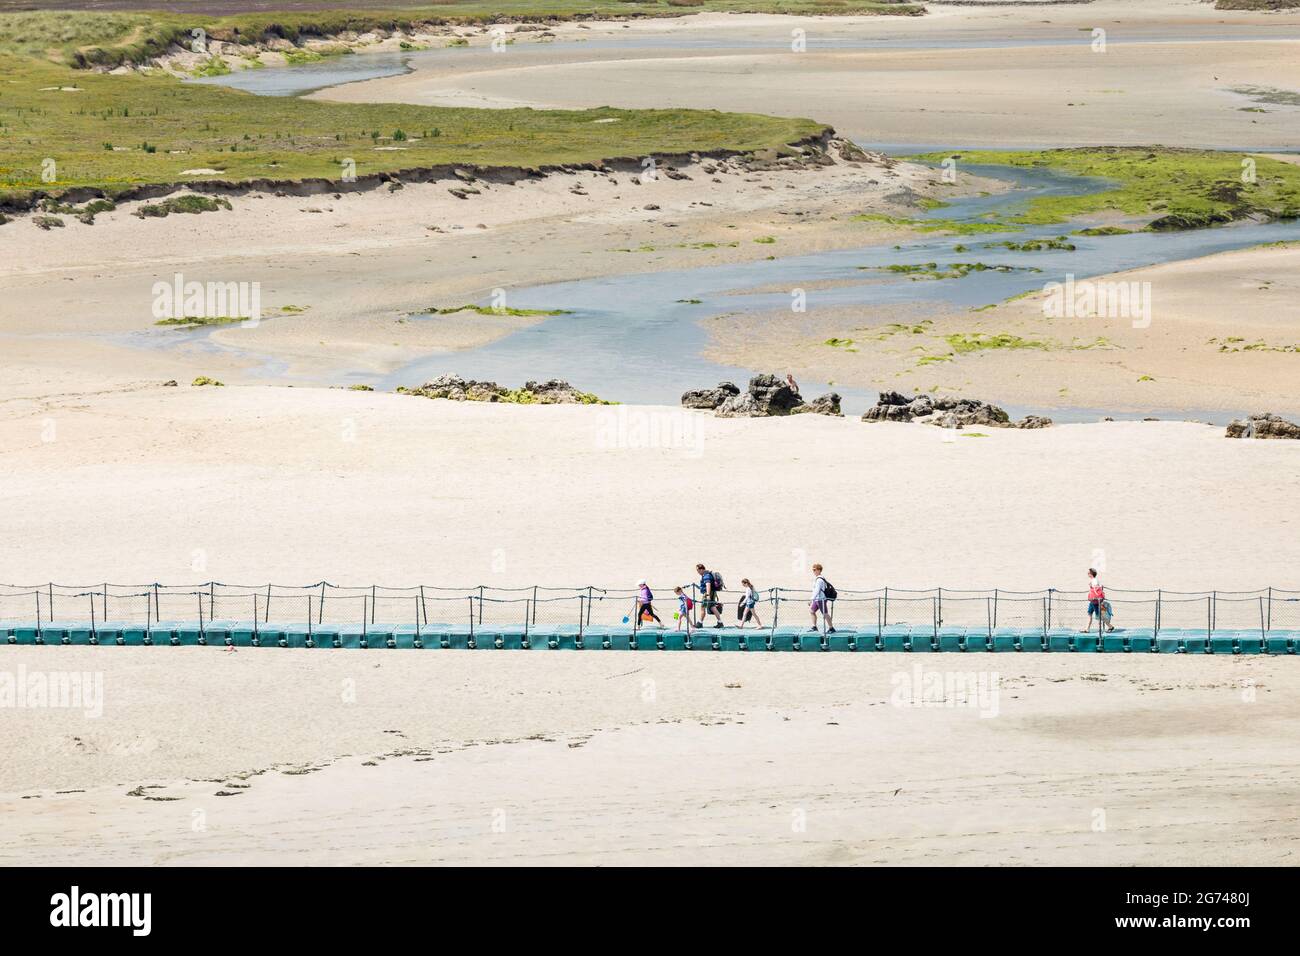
0,56,826,207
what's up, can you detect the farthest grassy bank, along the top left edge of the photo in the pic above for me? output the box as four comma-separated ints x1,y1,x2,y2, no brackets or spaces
0,0,926,66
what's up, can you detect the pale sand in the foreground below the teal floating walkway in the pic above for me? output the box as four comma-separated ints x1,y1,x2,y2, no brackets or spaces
0,648,1300,866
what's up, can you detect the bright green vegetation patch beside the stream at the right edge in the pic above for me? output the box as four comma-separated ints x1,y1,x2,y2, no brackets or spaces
914,147,1300,232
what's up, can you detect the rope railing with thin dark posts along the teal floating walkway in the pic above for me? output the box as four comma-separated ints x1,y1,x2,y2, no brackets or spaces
0,581,1300,640
